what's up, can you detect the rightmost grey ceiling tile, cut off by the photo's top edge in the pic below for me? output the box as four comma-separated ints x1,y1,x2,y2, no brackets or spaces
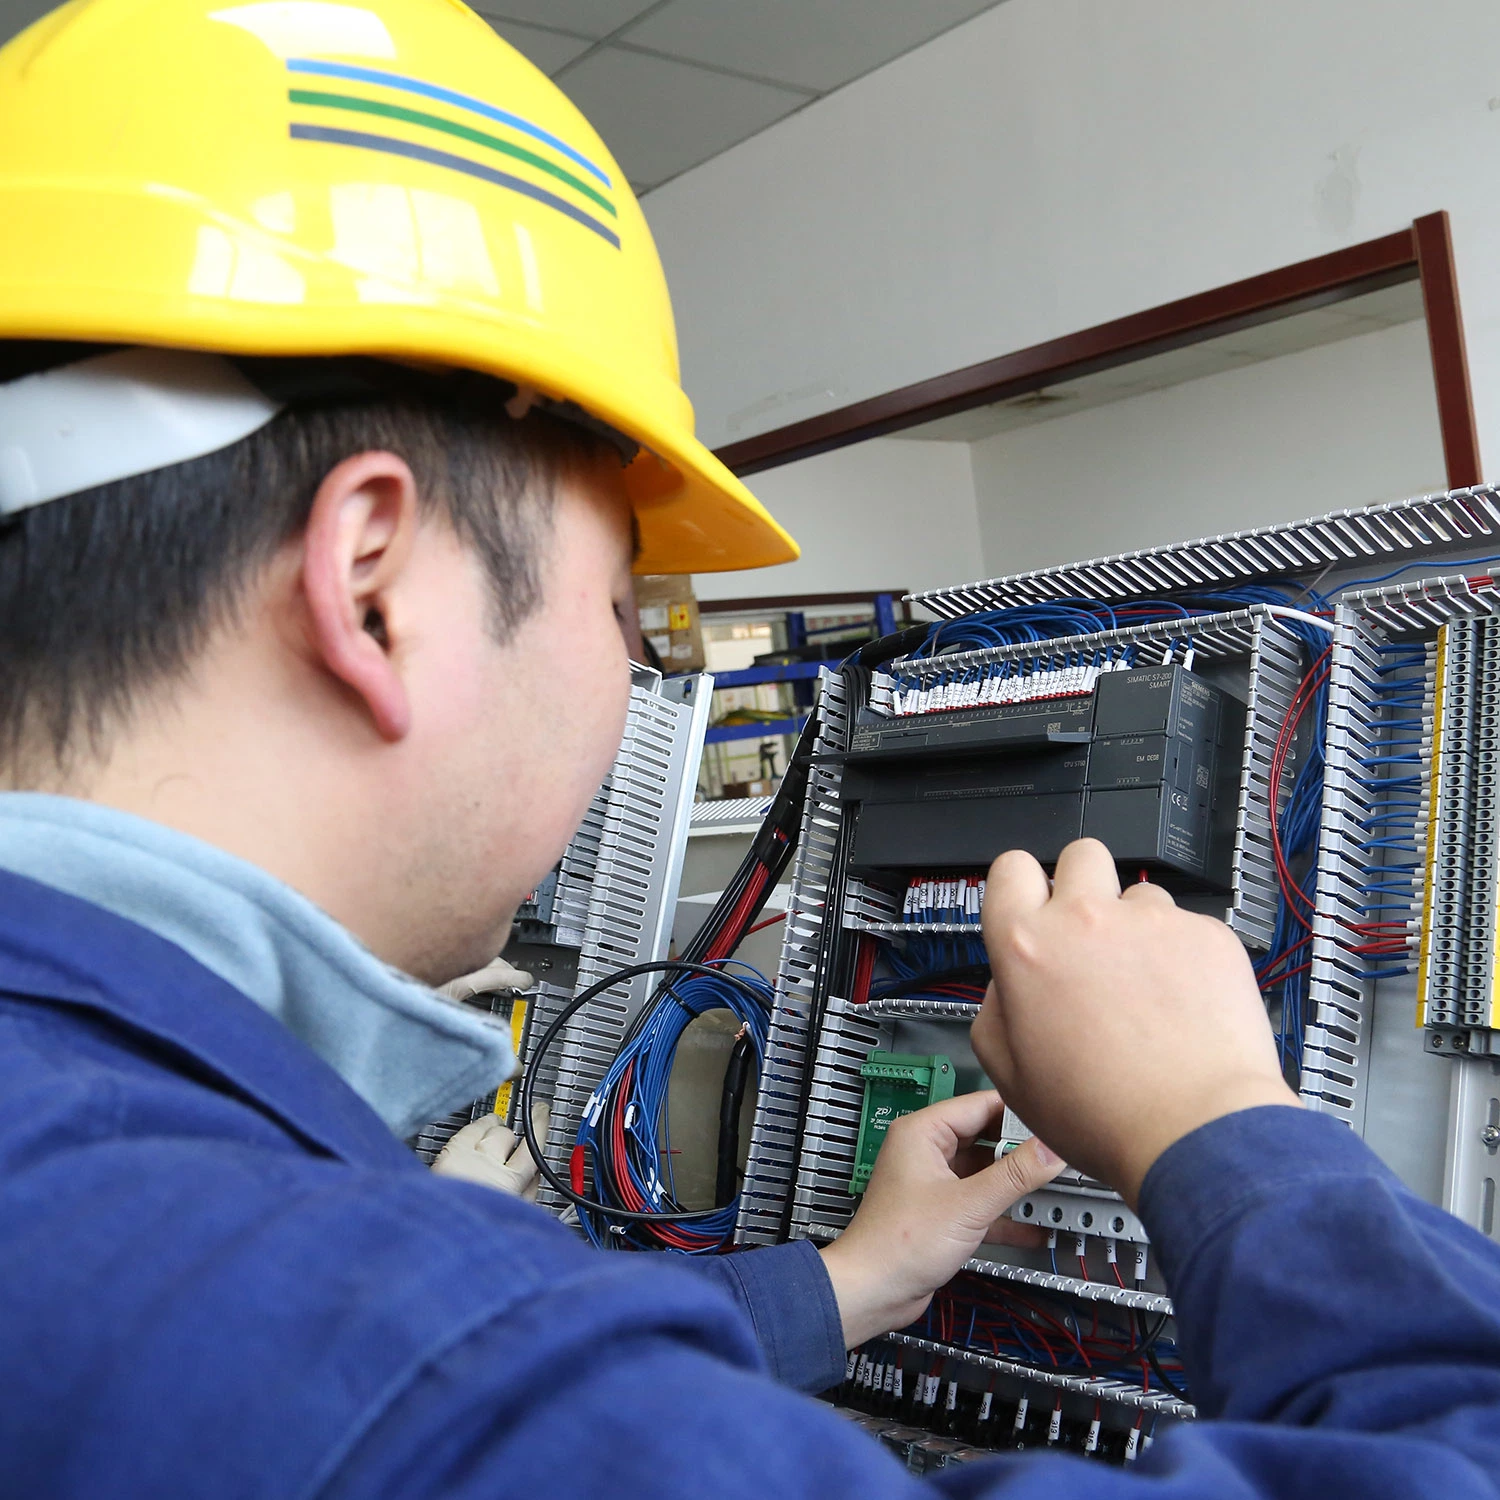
621,0,998,90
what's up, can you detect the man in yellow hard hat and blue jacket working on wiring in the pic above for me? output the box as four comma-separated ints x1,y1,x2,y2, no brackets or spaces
0,0,1500,1500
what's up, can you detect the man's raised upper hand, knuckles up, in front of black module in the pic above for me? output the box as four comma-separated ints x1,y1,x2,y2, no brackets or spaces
974,839,1298,1205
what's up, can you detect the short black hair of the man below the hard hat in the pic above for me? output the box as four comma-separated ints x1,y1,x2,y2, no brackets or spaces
0,344,618,774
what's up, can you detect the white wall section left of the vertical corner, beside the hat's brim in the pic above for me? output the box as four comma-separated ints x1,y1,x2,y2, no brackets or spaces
693,438,984,599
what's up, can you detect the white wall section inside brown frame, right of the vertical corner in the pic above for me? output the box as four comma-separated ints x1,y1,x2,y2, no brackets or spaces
950,323,1446,582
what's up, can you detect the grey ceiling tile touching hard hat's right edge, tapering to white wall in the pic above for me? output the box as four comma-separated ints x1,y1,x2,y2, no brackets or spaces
558,47,807,188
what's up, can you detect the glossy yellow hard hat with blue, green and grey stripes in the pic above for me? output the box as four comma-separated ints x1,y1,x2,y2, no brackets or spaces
0,0,797,573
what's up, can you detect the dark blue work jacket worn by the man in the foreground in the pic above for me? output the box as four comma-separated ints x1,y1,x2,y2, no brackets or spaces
0,873,1500,1500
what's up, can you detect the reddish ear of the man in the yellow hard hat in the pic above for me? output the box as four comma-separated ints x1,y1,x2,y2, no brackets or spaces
302,452,417,741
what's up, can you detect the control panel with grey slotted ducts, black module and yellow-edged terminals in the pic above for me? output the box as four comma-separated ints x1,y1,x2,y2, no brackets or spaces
737,486,1500,1467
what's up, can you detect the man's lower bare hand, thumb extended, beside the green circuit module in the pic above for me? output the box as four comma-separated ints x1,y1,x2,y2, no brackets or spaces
822,1091,1062,1349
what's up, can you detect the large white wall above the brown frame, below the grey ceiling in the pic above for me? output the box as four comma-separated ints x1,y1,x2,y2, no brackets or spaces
645,0,1500,480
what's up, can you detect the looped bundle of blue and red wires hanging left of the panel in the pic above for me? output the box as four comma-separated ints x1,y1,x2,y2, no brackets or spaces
572,960,773,1256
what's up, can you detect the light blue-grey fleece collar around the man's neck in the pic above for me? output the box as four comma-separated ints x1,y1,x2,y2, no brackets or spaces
0,792,516,1139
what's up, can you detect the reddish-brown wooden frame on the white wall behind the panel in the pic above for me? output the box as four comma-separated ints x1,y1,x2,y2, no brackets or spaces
719,212,1482,489
